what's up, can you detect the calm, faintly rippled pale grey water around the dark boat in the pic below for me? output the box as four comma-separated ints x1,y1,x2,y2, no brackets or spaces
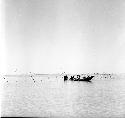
1,76,125,118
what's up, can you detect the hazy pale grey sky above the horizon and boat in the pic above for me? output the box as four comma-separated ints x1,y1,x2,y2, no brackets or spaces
3,0,125,73
